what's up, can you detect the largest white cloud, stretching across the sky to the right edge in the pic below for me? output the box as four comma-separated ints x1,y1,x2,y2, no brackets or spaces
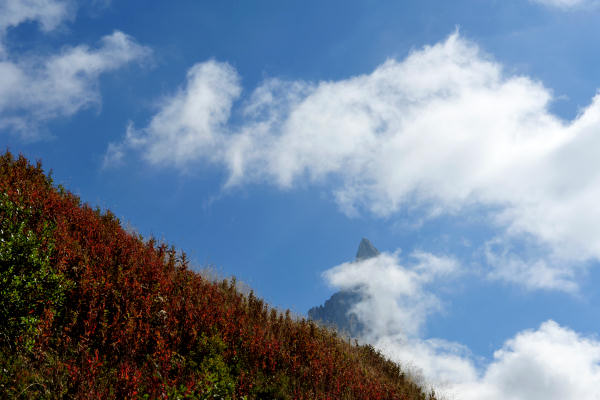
107,33,600,290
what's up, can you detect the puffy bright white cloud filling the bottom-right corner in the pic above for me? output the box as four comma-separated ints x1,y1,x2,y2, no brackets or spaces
451,321,600,400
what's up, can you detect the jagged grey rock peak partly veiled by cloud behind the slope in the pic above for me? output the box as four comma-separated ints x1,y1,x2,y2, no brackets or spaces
308,238,379,337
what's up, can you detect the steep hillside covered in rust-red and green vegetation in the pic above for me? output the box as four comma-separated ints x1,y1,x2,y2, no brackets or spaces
0,152,434,400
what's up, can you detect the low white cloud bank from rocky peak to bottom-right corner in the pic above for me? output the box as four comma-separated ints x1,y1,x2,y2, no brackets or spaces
323,253,600,400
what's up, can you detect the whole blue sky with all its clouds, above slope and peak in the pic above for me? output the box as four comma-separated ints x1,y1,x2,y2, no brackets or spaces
0,0,600,400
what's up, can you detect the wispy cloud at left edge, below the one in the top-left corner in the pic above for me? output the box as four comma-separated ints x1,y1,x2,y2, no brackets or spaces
0,31,150,138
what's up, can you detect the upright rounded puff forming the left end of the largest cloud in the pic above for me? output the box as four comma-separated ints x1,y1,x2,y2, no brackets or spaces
104,61,241,168
